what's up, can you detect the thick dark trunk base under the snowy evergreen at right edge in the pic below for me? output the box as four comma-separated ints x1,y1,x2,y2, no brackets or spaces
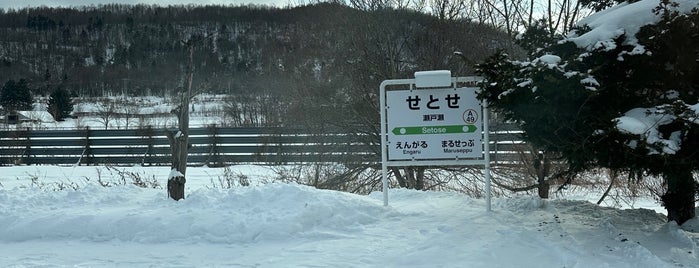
662,165,697,225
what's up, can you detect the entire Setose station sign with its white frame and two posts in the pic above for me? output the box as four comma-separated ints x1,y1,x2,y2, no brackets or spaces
380,71,490,211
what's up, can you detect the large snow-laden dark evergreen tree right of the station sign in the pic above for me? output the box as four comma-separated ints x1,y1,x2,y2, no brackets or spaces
479,0,699,224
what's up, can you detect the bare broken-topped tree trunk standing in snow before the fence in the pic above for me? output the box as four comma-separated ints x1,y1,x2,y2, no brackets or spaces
167,40,194,200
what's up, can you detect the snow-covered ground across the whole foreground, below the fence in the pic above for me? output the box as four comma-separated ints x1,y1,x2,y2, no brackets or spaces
0,166,699,268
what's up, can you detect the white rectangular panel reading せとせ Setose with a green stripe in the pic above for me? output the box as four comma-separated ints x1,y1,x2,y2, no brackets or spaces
386,88,483,161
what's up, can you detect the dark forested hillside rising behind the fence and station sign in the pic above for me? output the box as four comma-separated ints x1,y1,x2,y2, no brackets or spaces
0,3,512,124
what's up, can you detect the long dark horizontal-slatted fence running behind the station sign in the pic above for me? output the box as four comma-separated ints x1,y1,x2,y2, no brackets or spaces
0,125,522,166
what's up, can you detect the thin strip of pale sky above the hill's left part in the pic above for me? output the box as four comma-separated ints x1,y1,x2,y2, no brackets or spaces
0,0,298,9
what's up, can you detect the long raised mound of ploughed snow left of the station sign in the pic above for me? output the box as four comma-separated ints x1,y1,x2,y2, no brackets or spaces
0,184,385,243
